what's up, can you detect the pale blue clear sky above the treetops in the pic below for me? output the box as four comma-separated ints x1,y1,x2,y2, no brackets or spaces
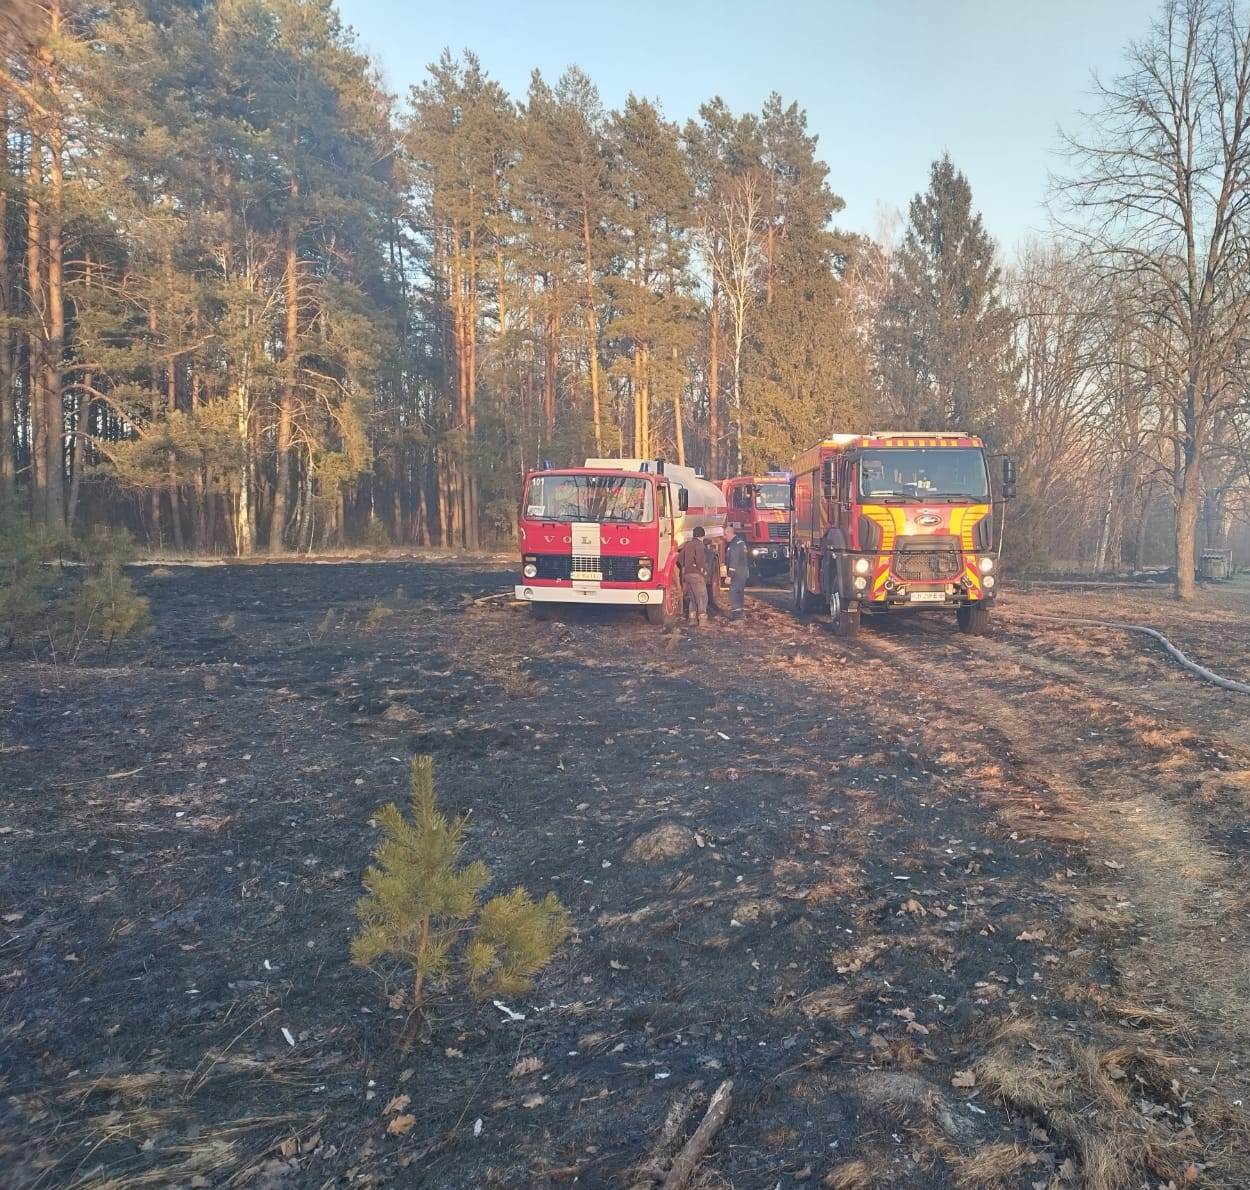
340,0,1159,255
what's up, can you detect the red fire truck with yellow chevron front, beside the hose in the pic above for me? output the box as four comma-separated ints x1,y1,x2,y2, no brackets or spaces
790,433,1016,636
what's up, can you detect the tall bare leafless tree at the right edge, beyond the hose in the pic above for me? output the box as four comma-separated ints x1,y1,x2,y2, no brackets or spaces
1060,0,1250,599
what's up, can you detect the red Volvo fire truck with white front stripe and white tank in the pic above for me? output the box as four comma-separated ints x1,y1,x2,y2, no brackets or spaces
516,459,725,626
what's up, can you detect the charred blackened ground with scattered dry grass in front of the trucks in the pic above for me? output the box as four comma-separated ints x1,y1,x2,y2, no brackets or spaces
0,563,1250,1188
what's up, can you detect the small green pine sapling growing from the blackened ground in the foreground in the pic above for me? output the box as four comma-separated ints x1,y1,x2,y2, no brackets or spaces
351,756,569,1009
